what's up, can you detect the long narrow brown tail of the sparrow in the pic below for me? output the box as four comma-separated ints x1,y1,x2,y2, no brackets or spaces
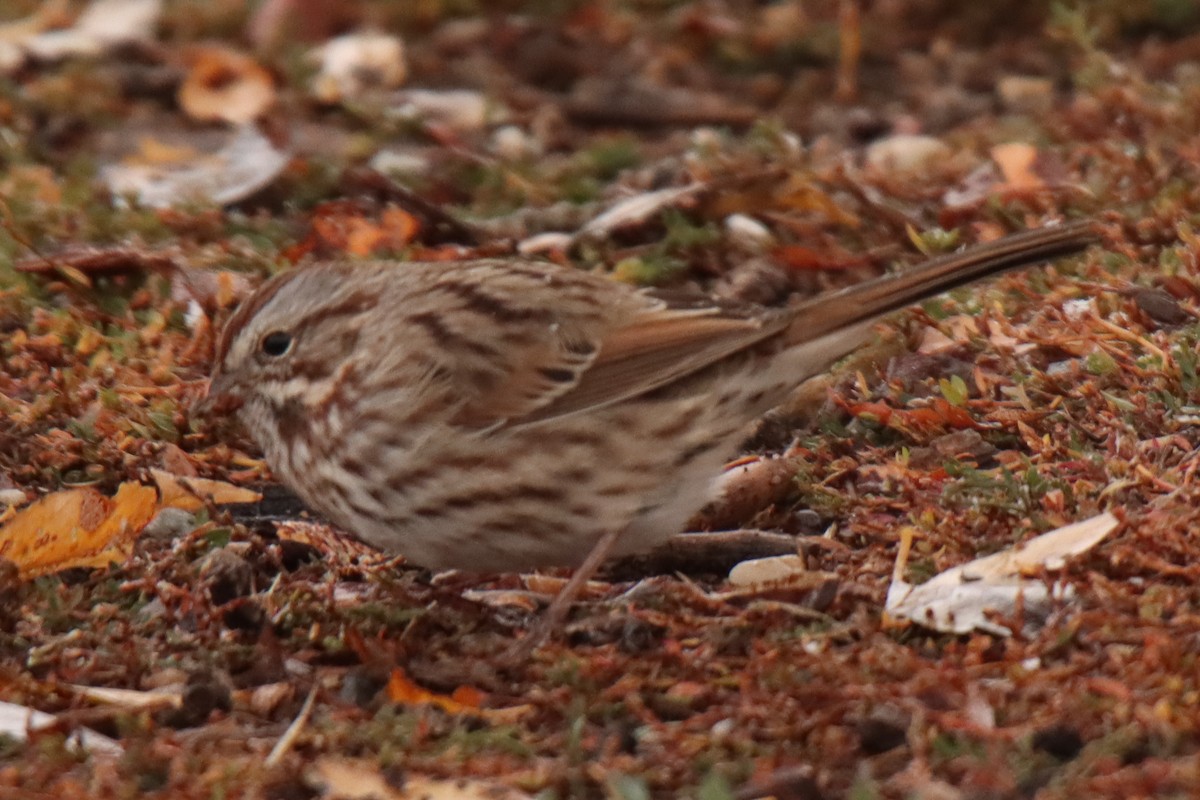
786,219,1100,343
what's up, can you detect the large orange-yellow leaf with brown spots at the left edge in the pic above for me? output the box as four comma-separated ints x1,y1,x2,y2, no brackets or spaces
0,483,157,578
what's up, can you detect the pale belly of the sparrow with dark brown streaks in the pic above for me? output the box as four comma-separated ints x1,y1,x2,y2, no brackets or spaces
289,397,744,572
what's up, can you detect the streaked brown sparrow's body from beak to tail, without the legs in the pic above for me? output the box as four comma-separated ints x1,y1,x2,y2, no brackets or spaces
204,217,1096,571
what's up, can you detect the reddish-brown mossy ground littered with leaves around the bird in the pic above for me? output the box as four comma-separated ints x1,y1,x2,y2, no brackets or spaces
0,0,1200,800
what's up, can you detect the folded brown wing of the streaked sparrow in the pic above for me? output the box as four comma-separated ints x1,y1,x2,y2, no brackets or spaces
409,261,788,428
